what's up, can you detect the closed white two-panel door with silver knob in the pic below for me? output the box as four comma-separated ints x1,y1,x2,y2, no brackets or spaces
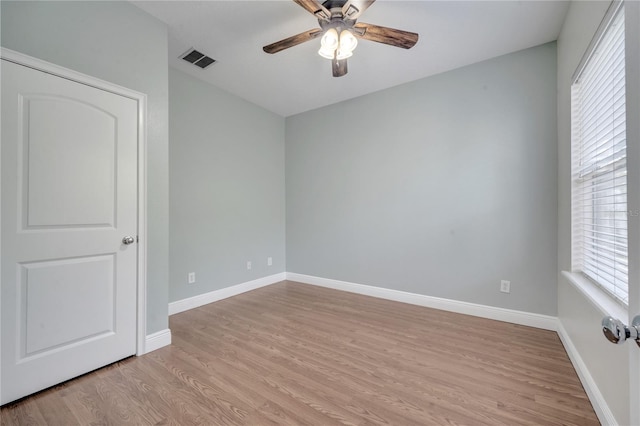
0,60,138,404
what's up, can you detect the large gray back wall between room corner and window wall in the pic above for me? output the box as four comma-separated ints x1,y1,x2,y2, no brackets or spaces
286,43,557,315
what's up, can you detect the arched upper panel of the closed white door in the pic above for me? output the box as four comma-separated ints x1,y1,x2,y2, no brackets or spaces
18,96,117,229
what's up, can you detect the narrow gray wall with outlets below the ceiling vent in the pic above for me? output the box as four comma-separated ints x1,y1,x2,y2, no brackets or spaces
169,69,285,301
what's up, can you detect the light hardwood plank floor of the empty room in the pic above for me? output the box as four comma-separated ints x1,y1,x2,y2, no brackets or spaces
0,282,599,426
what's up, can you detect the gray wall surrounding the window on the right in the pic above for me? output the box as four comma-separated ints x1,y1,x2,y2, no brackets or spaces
558,1,634,425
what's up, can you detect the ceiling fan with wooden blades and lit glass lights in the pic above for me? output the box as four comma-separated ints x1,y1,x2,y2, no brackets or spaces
262,0,418,77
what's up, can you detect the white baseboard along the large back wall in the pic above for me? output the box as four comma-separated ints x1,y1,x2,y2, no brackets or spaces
287,272,558,331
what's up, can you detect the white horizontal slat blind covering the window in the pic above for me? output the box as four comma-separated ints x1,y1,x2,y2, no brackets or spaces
571,1,629,304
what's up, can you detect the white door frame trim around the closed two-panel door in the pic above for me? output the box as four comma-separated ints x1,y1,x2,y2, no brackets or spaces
0,47,147,398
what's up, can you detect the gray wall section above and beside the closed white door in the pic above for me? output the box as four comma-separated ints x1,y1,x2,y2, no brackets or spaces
0,1,169,333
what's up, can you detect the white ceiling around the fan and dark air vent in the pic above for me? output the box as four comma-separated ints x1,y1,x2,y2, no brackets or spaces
133,0,568,117
